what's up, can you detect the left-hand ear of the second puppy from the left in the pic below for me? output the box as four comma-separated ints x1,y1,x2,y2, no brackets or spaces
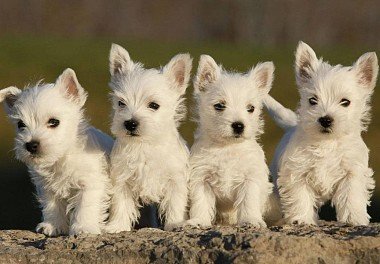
109,43,134,76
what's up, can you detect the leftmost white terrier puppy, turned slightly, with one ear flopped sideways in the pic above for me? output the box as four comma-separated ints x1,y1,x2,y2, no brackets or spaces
0,69,113,236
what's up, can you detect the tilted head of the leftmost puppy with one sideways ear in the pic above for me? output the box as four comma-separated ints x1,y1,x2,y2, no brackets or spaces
0,69,87,165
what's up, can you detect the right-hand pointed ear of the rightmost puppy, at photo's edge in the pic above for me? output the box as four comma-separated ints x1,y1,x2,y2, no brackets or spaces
353,52,379,91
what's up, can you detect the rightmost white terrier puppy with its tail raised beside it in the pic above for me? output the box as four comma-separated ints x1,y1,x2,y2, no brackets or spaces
265,42,379,225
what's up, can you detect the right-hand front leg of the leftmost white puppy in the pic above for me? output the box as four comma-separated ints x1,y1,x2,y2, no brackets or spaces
69,182,108,235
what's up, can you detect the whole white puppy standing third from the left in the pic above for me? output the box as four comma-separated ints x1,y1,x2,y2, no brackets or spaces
188,55,274,227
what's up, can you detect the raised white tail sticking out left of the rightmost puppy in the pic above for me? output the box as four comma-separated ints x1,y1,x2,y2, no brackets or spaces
264,94,298,130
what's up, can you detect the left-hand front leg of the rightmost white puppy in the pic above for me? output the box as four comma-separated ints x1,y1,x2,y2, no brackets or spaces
278,175,318,225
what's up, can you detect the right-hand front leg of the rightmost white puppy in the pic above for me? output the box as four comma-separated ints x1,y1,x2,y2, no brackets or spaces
332,167,375,225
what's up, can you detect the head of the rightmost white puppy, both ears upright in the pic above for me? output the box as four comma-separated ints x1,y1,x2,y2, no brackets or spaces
295,42,379,138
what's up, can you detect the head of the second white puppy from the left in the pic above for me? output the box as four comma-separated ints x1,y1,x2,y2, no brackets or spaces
110,44,192,141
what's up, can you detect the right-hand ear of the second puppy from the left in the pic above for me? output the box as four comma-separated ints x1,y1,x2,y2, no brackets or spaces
162,54,193,95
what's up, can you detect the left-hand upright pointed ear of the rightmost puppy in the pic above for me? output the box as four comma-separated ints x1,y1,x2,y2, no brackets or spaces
295,41,319,84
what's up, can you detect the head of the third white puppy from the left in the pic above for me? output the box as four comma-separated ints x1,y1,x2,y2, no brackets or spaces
194,55,274,142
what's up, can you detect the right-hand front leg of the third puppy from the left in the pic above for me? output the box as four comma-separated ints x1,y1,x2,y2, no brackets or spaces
234,179,266,227
